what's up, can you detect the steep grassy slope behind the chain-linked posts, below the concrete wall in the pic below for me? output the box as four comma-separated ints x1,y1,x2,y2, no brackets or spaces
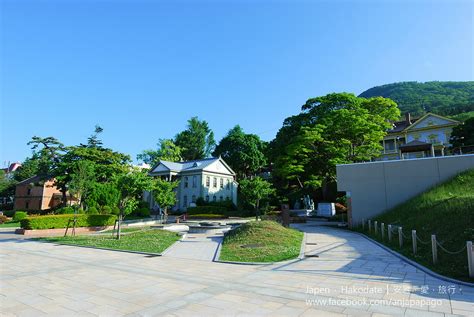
356,170,474,281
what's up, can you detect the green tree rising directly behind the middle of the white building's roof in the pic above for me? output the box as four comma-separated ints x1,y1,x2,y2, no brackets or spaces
175,117,216,161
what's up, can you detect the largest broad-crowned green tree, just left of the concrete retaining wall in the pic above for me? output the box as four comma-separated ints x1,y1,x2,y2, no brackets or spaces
272,93,400,197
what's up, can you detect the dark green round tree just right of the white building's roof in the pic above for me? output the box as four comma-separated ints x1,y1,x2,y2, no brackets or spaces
212,125,266,179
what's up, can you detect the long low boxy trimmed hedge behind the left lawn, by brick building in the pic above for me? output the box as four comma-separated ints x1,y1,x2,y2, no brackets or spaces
20,214,117,230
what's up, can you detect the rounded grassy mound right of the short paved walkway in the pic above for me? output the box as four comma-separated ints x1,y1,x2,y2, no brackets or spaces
220,221,303,262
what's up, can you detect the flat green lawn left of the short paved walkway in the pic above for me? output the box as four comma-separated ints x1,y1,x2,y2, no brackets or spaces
39,229,179,253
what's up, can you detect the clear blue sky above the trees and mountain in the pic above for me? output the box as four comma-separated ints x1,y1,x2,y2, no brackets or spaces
0,0,474,165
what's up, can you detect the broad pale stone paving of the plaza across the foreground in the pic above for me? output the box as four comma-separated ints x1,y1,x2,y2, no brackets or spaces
0,225,474,317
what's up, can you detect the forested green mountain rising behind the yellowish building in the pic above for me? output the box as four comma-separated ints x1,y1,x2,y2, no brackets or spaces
359,81,474,116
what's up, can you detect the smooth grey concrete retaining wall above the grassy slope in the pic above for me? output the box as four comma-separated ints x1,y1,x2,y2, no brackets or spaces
337,155,474,225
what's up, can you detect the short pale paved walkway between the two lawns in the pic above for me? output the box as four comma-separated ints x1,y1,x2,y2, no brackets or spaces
164,234,223,261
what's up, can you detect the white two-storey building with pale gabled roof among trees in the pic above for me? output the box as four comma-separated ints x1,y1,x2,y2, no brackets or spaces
148,157,238,211
